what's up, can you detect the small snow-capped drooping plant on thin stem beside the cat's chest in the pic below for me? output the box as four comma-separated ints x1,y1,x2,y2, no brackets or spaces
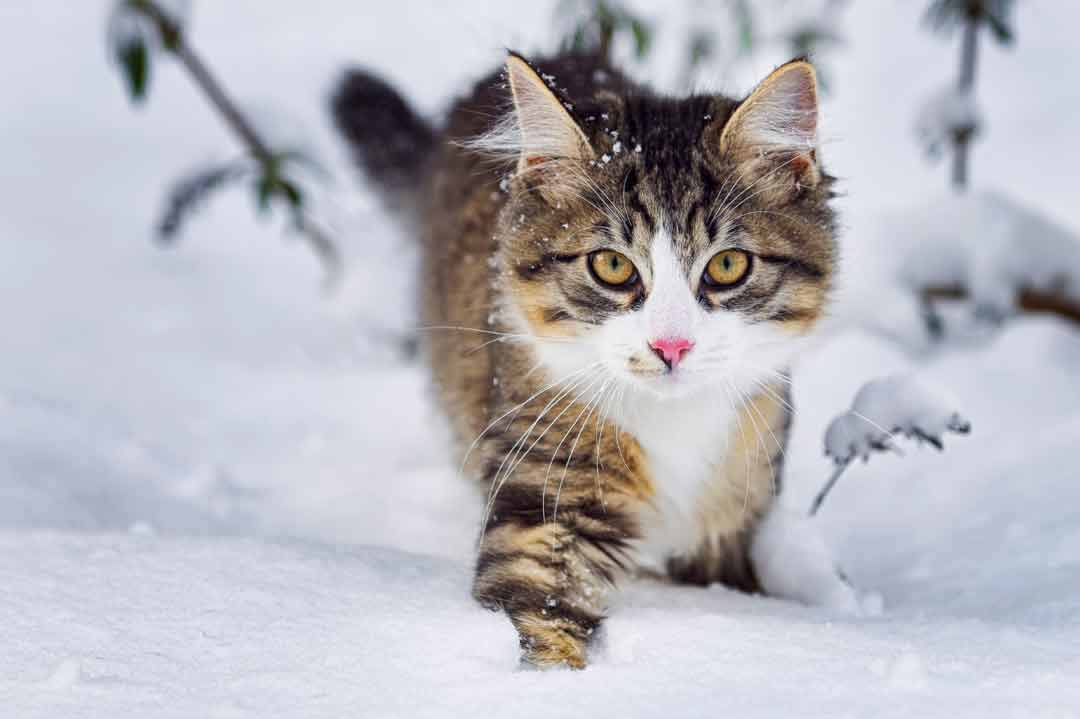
810,375,971,516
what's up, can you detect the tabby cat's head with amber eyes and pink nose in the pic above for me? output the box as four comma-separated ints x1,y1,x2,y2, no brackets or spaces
487,55,836,398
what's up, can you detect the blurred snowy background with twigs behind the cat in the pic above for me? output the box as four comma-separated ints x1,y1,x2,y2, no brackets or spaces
0,0,1080,570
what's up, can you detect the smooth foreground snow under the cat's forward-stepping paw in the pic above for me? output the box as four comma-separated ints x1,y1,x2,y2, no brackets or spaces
8,500,1080,718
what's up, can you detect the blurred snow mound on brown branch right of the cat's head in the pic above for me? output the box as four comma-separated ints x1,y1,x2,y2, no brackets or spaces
845,191,1080,350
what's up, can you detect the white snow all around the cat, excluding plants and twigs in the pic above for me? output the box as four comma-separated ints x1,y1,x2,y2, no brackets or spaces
0,0,1080,718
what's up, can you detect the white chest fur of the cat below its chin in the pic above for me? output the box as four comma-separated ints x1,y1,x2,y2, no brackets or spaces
622,388,735,568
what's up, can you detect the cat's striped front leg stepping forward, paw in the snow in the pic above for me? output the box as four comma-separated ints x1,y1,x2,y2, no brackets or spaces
473,462,633,669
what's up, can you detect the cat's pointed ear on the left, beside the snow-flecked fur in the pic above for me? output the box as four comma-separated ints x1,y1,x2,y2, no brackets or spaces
507,54,593,173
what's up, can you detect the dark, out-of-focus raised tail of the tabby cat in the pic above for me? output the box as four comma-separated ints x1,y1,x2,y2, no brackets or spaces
330,69,435,217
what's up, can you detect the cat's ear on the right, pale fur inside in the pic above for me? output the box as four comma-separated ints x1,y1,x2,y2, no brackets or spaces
719,59,821,189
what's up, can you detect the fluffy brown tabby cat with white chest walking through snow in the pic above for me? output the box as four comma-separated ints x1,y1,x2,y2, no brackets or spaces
332,53,837,668
